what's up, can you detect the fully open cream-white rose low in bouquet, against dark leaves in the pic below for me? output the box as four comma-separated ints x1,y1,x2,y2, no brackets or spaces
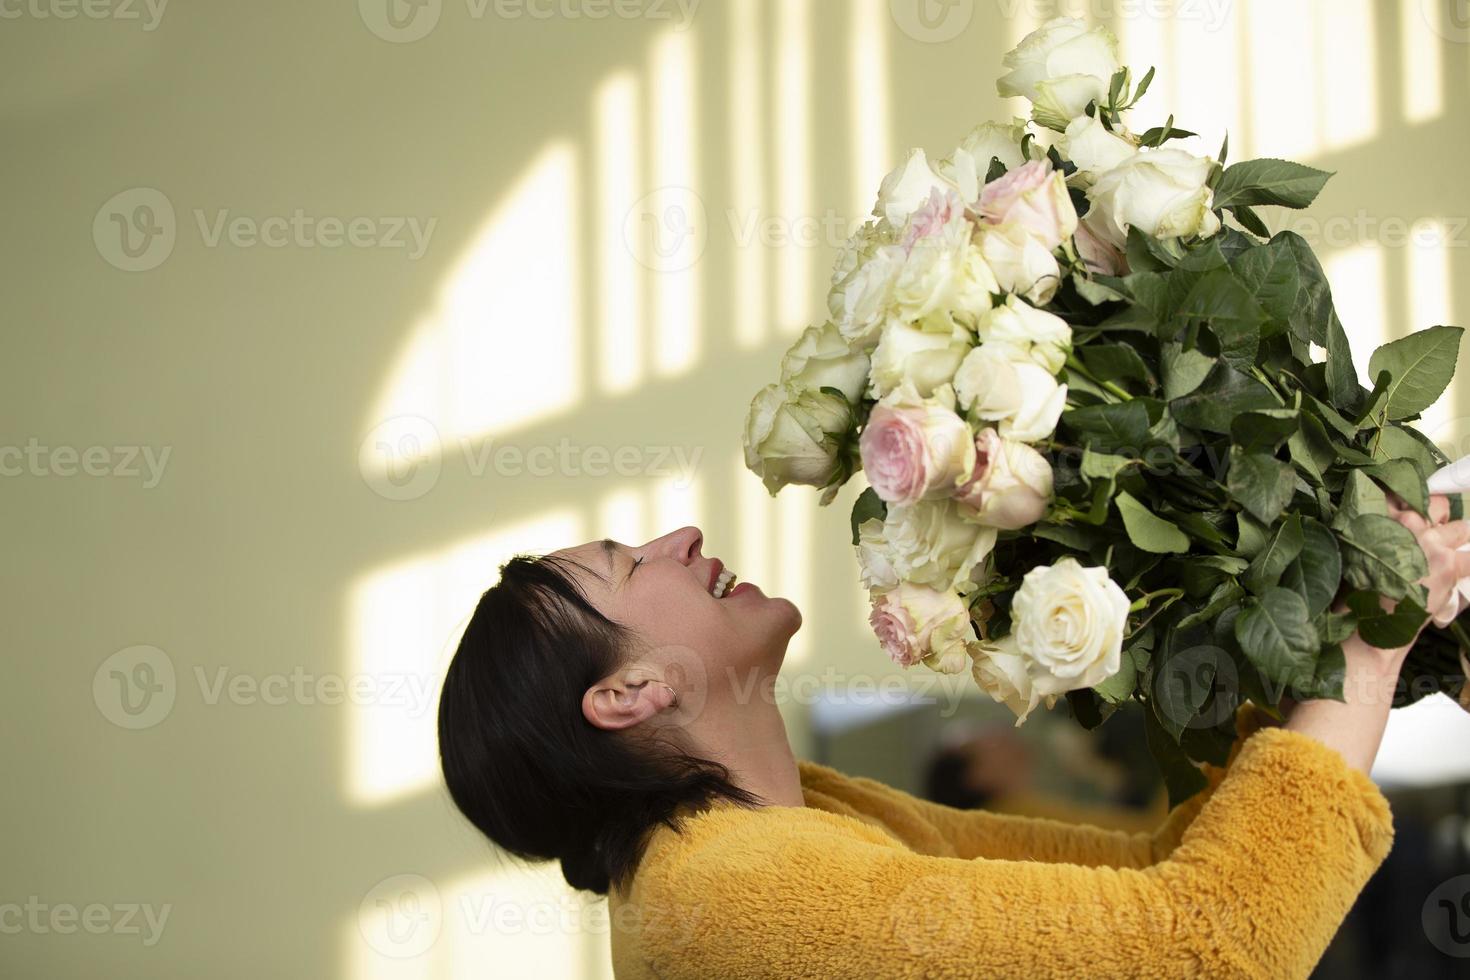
1011,558,1129,695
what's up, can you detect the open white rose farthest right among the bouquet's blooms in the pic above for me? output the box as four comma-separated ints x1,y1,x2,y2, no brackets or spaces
1088,147,1220,248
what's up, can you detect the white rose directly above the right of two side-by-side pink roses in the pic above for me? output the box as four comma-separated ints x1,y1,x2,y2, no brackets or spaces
954,341,1067,442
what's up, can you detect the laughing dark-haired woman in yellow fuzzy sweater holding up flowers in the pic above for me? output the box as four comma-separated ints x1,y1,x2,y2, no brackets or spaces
440,498,1470,980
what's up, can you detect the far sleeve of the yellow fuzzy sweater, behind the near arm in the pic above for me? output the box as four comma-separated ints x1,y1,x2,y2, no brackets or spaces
829,702,1270,868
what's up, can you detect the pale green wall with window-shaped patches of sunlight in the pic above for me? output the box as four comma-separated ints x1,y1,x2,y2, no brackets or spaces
0,0,1470,980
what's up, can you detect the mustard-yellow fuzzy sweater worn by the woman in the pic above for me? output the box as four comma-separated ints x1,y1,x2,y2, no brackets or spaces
609,705,1394,980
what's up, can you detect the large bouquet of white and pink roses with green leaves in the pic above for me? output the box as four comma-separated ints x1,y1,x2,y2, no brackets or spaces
744,18,1470,793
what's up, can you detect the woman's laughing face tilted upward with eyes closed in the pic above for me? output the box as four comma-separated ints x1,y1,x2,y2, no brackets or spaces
553,527,801,728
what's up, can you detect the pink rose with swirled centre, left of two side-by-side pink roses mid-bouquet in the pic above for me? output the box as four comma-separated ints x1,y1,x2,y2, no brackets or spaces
858,382,975,504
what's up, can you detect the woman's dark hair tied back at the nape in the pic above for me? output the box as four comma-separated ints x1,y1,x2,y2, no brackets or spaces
438,555,760,895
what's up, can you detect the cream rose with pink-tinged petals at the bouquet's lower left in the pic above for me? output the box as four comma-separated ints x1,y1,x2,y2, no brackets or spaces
867,582,975,673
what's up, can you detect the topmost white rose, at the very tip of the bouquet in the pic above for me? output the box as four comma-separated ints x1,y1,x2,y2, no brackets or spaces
997,18,1122,131
